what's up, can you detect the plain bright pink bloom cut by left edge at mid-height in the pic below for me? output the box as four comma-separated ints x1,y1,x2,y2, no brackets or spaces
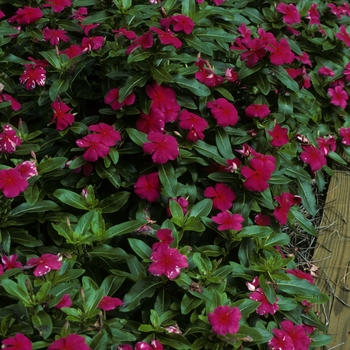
0,169,28,198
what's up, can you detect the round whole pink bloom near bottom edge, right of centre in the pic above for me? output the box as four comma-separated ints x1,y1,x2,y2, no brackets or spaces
208,305,242,336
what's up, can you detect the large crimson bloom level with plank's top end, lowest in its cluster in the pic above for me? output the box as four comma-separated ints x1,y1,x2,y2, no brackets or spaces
241,159,271,192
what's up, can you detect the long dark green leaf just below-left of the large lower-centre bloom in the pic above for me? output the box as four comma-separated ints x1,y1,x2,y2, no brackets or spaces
120,276,163,312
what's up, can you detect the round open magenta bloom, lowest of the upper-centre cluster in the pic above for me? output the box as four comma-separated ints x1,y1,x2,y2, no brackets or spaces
143,132,179,164
